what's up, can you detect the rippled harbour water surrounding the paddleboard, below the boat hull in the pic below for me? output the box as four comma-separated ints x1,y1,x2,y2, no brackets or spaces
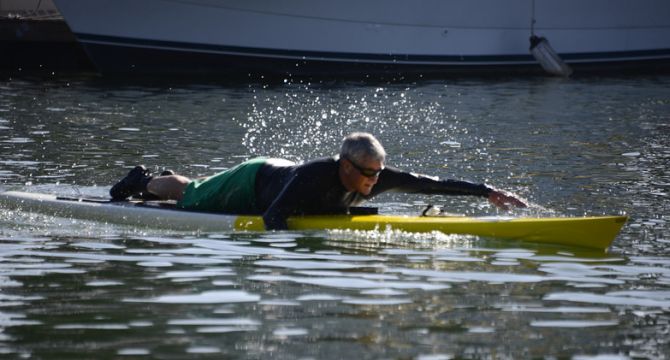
0,76,670,360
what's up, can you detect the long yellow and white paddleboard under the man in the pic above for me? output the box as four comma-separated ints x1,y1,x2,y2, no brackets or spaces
0,191,627,250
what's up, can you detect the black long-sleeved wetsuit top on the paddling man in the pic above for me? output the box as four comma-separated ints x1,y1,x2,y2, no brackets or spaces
256,158,492,230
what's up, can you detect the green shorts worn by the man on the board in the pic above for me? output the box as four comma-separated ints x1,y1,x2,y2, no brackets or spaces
177,158,266,214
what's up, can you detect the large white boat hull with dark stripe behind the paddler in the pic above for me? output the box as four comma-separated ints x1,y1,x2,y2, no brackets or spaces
51,0,670,74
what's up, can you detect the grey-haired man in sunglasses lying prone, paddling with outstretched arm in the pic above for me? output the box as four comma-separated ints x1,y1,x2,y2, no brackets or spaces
110,133,526,230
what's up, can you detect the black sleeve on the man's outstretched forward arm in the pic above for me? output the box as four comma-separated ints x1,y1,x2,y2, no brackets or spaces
372,167,493,197
